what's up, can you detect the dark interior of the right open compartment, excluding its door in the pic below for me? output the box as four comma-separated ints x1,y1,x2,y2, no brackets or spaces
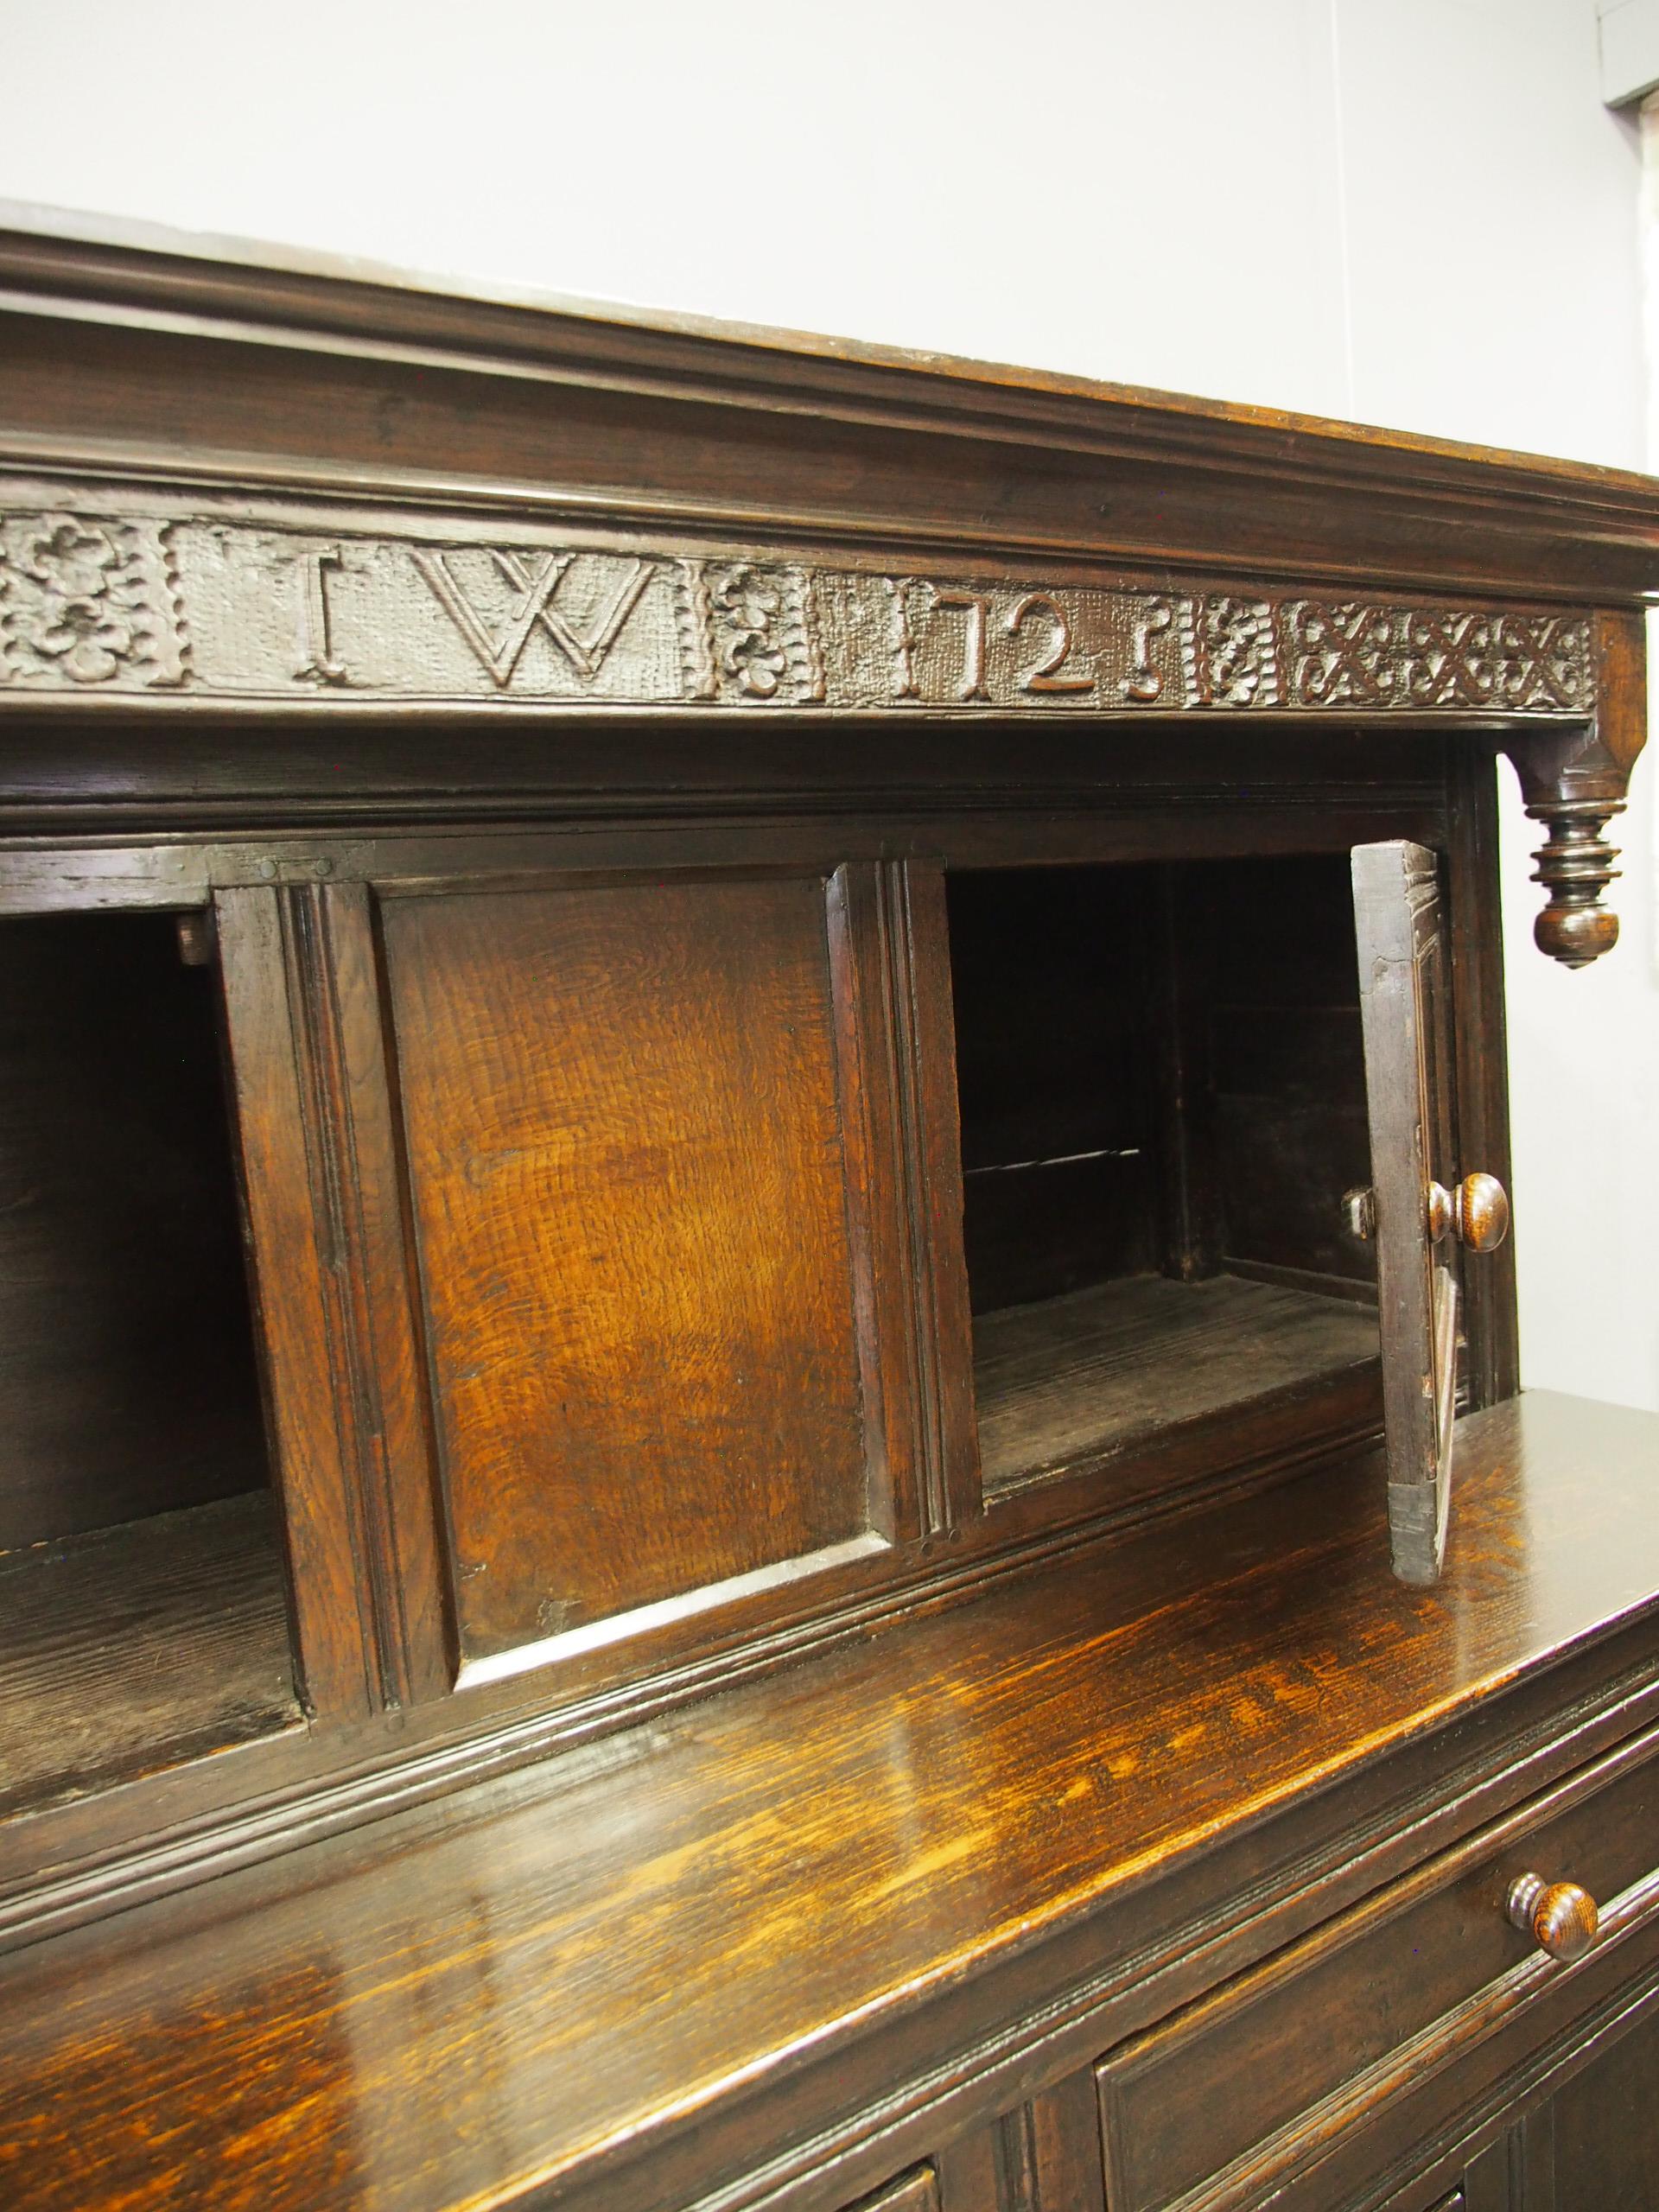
949,854,1380,1497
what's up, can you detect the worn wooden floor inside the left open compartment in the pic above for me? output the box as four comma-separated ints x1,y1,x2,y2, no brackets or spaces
0,1491,301,1814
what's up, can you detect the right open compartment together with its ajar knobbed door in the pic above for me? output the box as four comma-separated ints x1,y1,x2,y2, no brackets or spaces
947,841,1509,1581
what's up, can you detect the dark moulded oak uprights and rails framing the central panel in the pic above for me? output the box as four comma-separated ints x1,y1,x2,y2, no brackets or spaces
0,814,1442,1955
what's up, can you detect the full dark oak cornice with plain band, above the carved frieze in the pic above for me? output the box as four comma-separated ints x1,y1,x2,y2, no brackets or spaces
0,217,1655,600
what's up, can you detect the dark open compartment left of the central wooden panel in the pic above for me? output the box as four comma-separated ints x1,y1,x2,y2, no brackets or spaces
0,913,299,1814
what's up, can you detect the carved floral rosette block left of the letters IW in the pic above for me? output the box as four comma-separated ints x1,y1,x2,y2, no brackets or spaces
0,513,183,686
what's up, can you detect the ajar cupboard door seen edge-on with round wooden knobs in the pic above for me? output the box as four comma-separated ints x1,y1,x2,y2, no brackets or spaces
1344,841,1509,1584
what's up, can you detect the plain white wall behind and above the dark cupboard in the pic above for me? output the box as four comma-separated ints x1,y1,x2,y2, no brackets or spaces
0,0,1659,1407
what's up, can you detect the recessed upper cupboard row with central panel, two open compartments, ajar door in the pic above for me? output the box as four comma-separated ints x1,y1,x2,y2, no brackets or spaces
0,836,1503,1809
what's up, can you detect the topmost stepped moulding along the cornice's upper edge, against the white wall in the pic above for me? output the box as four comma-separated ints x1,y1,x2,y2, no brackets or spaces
0,210,1659,597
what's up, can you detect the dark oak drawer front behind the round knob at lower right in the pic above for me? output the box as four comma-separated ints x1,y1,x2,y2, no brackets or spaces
1097,1732,1659,2212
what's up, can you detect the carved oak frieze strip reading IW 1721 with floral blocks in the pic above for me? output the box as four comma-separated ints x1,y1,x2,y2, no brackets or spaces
0,498,1595,715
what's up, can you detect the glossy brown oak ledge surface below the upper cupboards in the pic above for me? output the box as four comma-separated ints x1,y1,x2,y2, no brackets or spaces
0,1394,1659,2212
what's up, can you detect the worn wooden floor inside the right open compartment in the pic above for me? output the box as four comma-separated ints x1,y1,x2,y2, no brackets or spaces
973,1274,1378,1491
